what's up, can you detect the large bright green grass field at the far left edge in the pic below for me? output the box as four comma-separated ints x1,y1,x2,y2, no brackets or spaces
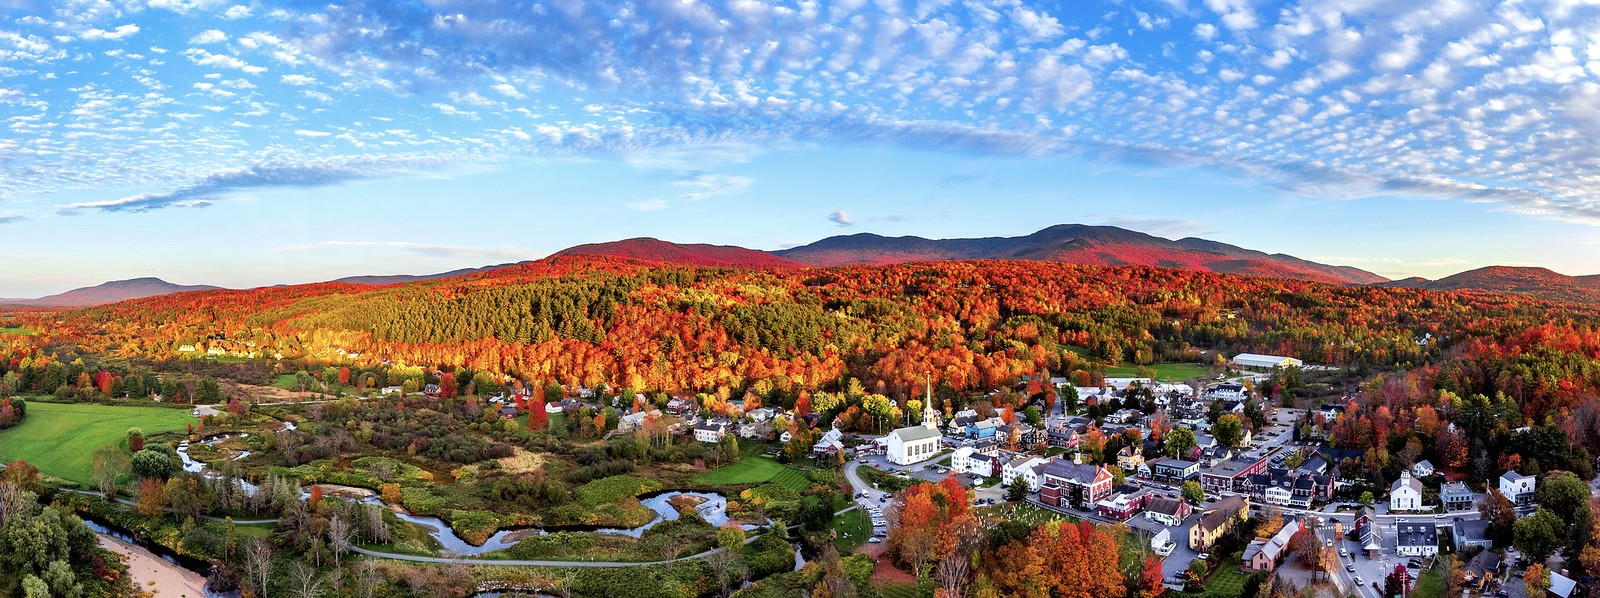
0,401,197,484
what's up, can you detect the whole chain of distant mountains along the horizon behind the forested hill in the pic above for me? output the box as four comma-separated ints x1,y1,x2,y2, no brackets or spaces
0,224,1600,307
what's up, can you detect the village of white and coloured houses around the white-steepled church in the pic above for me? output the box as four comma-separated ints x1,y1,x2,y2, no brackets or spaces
566,353,1600,598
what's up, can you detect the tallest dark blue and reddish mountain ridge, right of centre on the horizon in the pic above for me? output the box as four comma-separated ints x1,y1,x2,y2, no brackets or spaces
773,224,1387,285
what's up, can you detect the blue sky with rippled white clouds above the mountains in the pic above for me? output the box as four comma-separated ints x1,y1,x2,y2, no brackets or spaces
0,0,1600,297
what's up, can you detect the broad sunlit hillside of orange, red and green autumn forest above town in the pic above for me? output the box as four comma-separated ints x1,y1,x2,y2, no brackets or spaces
9,256,1594,409
